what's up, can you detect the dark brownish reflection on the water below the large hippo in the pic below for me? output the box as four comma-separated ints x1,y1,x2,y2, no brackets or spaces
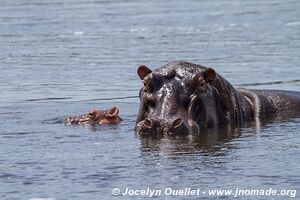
136,116,297,155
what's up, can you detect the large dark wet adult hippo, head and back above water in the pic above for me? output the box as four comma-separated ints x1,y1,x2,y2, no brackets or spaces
135,62,300,135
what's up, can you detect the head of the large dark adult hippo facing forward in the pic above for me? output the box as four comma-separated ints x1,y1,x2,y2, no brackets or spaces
136,65,217,135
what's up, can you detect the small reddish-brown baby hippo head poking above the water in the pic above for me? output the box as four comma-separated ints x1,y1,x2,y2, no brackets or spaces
64,107,122,125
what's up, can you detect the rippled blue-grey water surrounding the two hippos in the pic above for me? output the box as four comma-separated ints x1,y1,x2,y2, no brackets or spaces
0,0,300,200
